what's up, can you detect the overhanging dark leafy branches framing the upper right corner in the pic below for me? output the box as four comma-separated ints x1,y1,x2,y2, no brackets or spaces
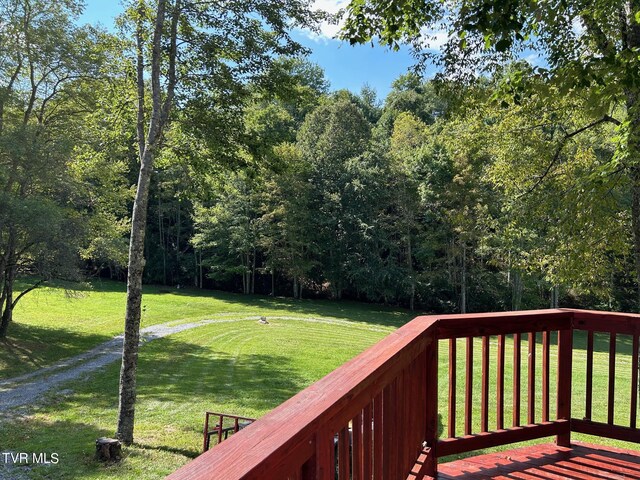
343,0,640,308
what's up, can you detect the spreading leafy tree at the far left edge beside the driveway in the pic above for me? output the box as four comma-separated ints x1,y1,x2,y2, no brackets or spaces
0,0,104,337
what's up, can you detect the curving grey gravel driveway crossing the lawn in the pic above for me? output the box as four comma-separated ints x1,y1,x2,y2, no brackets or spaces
0,313,389,412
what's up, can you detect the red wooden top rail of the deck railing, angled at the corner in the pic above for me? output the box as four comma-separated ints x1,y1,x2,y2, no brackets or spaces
168,309,640,480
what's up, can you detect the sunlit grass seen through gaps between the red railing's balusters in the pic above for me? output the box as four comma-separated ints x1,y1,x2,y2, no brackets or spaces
438,331,640,461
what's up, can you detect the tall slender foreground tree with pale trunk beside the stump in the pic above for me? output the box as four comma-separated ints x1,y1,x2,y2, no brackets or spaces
117,0,323,444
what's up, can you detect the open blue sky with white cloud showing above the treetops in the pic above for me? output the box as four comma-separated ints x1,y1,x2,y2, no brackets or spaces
81,0,428,99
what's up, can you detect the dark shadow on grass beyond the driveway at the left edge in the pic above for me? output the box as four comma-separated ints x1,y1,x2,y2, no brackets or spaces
0,323,111,379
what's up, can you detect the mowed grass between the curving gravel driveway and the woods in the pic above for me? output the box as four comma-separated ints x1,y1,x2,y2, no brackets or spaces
0,281,413,380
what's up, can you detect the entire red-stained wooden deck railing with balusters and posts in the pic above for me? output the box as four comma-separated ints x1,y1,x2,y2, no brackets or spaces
169,310,640,480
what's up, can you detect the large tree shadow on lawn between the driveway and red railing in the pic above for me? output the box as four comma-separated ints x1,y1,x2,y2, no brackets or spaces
17,330,316,458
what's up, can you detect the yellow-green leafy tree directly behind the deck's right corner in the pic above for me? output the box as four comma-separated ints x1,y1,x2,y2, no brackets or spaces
481,91,632,304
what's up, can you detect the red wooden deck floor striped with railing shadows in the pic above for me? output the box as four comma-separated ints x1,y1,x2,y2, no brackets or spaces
438,442,640,480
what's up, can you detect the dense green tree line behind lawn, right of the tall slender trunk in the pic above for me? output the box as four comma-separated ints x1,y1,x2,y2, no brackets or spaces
155,72,635,312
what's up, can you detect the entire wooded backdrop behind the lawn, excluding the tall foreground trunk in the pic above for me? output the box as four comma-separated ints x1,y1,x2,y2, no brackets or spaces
0,0,638,344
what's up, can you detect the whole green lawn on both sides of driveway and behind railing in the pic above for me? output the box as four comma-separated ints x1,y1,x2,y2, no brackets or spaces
0,282,631,479
